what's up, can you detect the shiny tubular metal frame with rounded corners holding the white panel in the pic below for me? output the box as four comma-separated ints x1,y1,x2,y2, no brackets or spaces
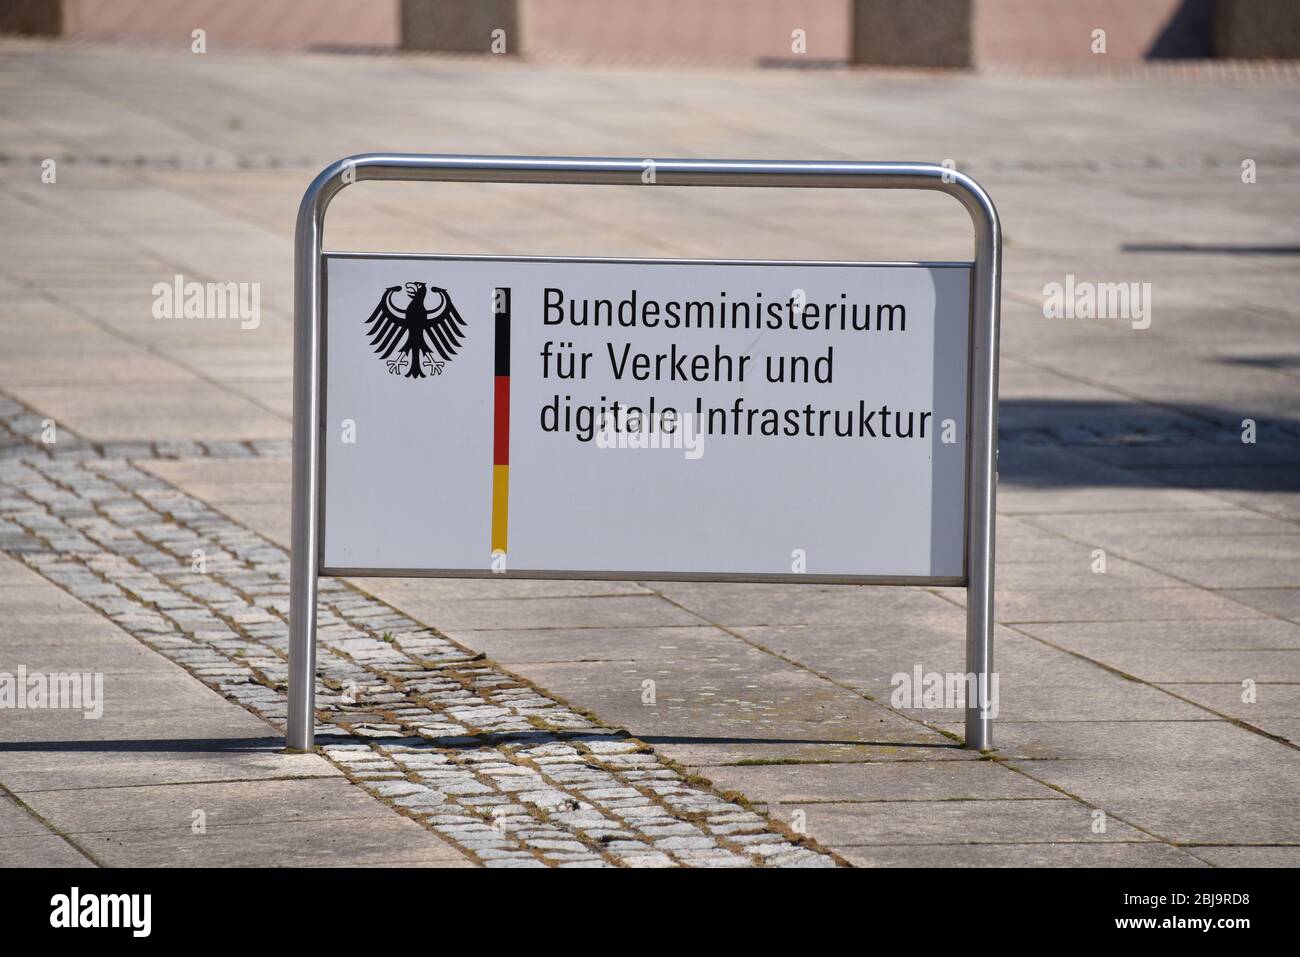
285,153,1002,750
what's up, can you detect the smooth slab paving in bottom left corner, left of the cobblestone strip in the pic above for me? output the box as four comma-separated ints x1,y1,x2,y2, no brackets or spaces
0,557,467,866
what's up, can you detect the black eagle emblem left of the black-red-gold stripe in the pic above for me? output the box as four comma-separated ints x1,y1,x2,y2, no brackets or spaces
365,282,465,378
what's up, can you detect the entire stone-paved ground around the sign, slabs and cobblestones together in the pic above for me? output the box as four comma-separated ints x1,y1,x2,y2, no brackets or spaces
0,42,1300,866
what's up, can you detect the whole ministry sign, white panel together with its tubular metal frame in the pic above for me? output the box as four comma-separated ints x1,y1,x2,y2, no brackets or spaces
285,153,1002,750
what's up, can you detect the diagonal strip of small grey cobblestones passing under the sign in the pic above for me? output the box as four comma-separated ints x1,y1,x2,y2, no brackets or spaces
0,410,835,867
